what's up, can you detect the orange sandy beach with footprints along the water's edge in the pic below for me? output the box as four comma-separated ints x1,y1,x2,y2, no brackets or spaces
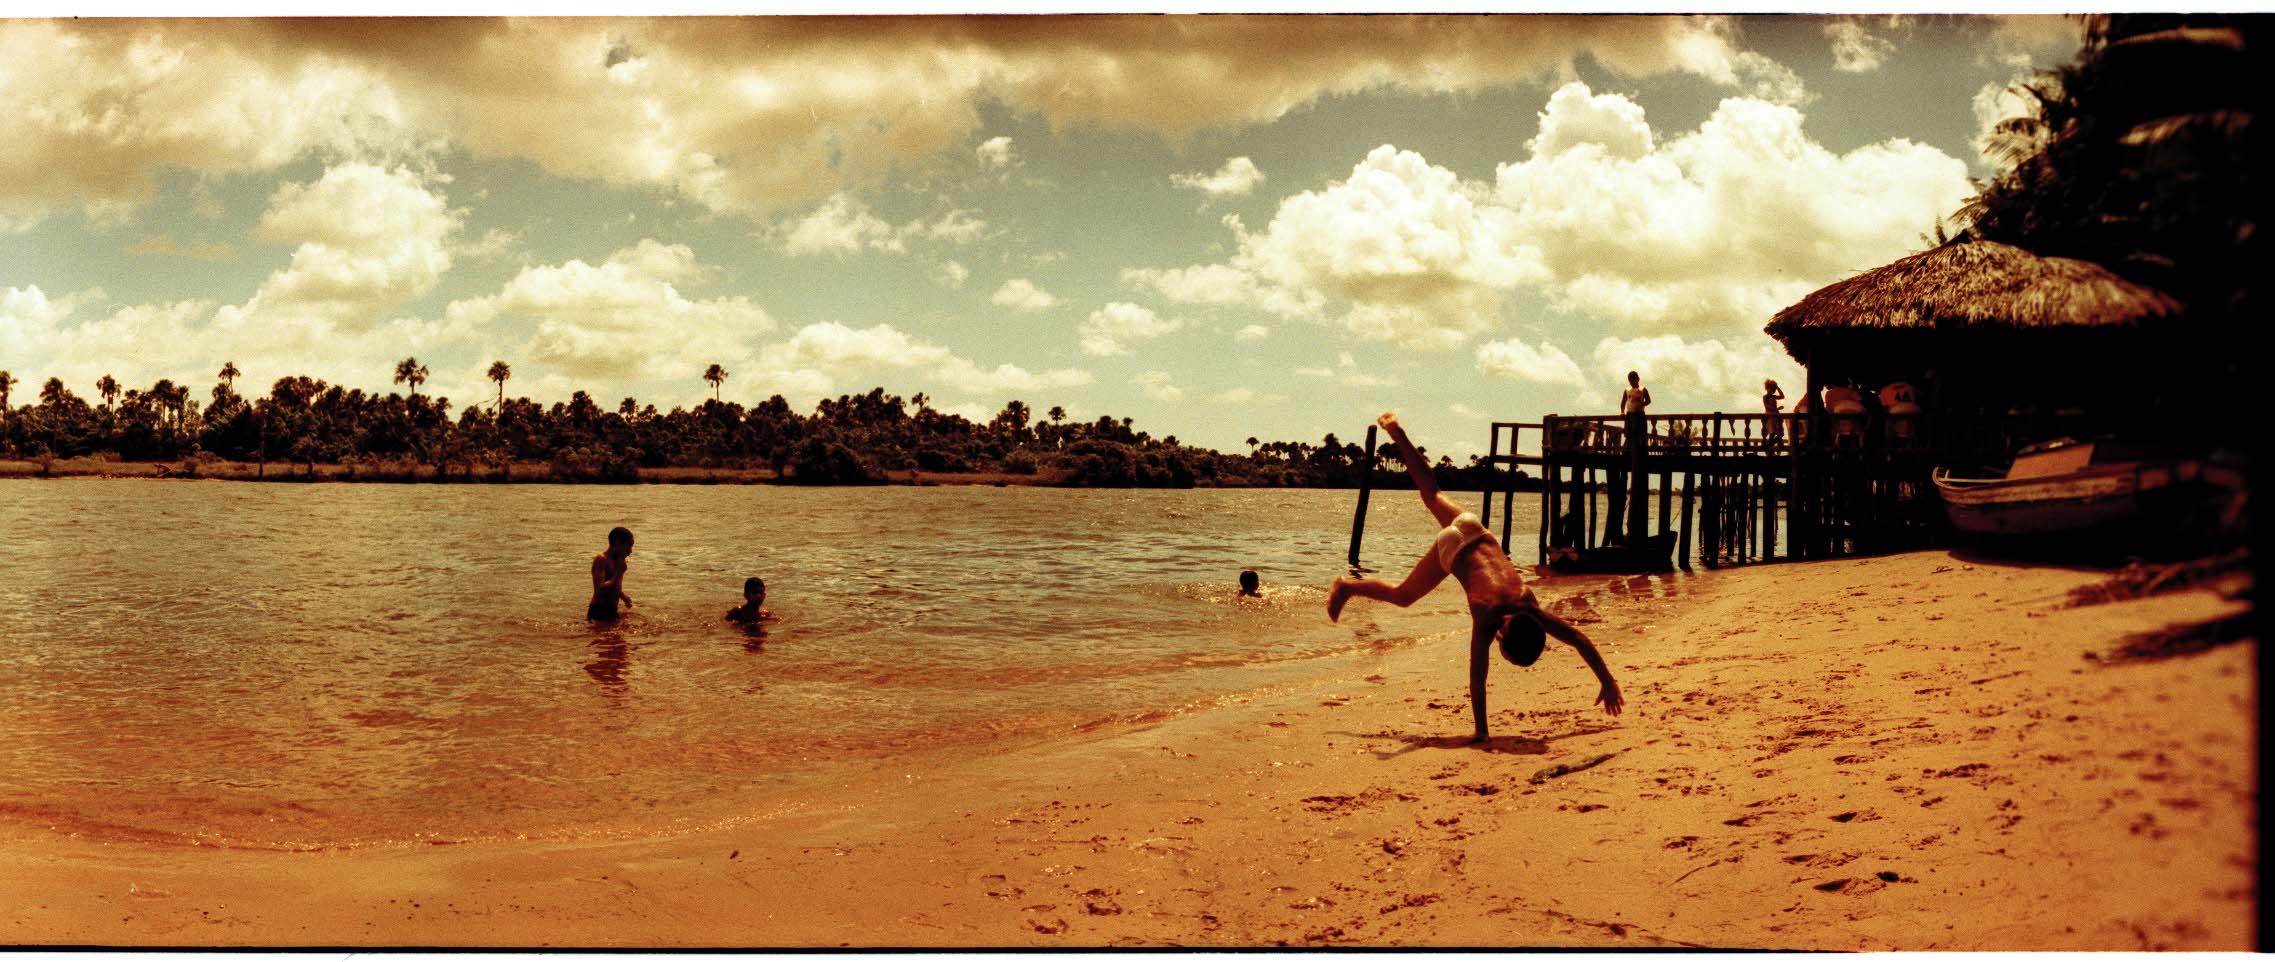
0,553,2257,951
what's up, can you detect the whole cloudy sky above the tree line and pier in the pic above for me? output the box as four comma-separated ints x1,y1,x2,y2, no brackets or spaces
0,16,2082,455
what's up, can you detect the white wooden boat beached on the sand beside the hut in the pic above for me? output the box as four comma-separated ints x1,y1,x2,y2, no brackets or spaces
1936,441,2216,537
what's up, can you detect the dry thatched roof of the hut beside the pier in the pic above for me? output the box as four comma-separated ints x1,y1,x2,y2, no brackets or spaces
1765,241,2179,341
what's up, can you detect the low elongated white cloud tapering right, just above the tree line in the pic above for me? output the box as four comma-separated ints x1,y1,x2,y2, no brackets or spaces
753,321,1092,396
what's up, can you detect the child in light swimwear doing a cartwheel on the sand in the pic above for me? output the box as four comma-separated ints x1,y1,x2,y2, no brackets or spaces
1326,414,1622,744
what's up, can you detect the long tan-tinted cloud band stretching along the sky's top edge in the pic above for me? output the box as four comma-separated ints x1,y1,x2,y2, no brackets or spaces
0,16,1829,227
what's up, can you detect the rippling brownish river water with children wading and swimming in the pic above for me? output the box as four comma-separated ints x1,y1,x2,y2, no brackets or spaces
0,480,1536,848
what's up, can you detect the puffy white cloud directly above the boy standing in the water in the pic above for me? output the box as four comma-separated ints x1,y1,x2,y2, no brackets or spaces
444,239,774,382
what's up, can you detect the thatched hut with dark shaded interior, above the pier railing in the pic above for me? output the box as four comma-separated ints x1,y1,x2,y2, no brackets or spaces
1765,241,2182,432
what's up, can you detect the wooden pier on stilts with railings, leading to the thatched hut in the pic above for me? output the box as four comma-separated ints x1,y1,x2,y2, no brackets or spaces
1483,412,1974,569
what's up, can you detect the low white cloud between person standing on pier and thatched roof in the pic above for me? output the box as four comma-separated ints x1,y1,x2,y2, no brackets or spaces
1595,334,1804,412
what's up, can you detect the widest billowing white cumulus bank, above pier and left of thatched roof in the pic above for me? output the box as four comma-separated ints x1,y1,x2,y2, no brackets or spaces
1122,82,1970,348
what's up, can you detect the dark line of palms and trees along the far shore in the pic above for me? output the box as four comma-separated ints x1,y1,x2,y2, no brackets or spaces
0,357,1519,487
